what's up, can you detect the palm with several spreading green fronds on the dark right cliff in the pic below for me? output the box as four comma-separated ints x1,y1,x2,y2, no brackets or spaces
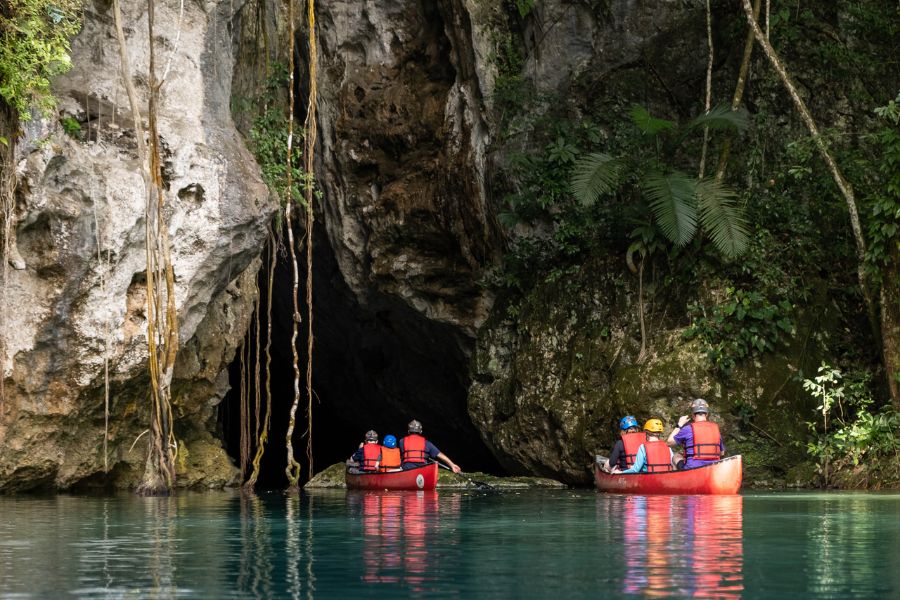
571,106,748,258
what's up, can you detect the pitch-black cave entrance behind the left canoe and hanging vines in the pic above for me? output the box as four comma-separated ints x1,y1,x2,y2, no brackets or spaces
219,222,500,489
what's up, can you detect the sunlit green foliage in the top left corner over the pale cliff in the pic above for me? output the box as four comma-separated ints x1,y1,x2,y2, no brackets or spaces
0,0,81,121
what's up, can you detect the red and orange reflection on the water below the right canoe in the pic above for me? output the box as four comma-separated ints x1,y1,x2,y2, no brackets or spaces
613,496,744,598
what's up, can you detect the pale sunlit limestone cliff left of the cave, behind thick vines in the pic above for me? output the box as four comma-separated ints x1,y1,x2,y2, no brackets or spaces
0,0,274,491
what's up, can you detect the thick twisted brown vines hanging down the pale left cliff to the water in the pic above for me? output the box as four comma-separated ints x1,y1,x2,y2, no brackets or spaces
113,0,178,495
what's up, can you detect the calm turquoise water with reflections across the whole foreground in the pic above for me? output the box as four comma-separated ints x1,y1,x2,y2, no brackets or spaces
0,490,900,600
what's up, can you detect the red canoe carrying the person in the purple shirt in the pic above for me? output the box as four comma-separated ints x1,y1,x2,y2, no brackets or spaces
594,455,743,494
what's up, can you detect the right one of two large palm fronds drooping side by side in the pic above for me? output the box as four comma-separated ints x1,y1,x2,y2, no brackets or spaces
697,179,749,258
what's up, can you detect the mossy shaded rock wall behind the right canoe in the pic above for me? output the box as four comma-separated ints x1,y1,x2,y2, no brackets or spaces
469,261,818,485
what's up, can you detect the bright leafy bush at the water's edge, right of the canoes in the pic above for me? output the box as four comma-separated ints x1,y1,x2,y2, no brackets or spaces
803,362,900,485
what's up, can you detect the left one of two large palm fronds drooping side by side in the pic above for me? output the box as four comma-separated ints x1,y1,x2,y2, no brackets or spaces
642,171,697,246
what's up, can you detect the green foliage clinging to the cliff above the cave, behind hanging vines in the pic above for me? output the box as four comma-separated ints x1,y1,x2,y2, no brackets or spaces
248,63,309,210
